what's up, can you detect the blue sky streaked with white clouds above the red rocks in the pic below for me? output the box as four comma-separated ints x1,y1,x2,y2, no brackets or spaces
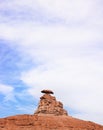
0,0,103,125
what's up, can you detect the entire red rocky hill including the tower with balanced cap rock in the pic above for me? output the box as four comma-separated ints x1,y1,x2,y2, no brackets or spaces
0,90,103,130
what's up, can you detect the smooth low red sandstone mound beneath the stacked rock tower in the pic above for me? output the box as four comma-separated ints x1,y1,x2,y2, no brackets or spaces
0,114,103,130
